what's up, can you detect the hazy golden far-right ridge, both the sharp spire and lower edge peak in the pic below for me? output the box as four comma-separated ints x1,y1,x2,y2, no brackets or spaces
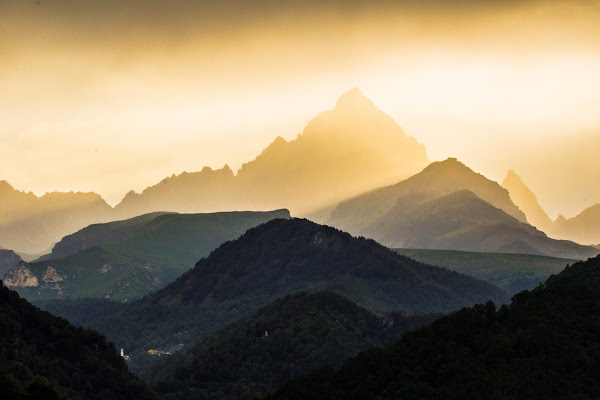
502,170,600,245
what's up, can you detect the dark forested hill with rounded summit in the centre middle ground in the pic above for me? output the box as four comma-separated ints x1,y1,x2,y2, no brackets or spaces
38,219,508,372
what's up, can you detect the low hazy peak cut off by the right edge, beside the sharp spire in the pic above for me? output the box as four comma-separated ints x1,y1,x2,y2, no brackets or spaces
550,204,600,244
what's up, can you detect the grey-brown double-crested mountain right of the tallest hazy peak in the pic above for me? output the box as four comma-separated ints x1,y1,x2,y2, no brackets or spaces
328,159,597,259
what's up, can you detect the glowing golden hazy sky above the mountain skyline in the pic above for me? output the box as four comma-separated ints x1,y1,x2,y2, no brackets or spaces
0,0,600,217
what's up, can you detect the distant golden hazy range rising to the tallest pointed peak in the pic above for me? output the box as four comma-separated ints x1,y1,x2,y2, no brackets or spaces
0,89,429,256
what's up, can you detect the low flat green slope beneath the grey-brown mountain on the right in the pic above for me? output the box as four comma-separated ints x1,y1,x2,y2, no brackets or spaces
394,249,577,294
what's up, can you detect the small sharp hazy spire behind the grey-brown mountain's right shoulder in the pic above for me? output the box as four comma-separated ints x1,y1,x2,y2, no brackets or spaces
502,169,552,232
